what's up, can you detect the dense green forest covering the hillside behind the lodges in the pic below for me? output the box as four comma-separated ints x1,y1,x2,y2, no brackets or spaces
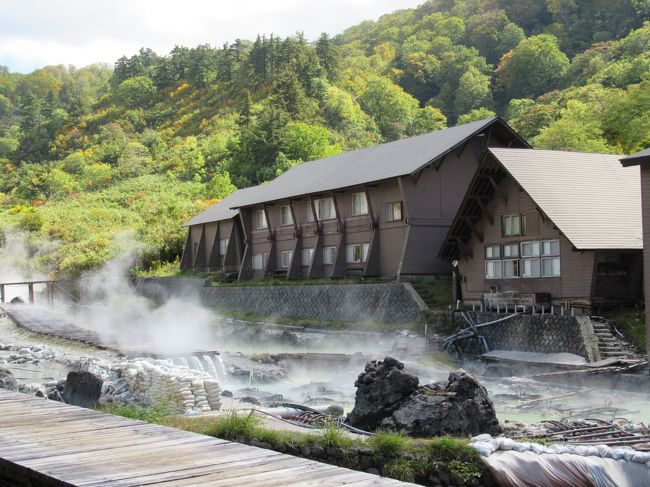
0,0,650,276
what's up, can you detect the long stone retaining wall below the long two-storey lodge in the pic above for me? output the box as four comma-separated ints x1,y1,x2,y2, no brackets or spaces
137,278,426,323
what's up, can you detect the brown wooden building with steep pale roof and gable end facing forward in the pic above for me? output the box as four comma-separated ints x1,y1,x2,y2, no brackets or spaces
439,148,650,308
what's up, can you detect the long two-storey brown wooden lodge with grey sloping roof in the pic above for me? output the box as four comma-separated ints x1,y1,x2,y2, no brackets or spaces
181,117,529,279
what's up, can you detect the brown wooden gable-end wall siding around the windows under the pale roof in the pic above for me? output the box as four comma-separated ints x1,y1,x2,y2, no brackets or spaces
459,172,595,300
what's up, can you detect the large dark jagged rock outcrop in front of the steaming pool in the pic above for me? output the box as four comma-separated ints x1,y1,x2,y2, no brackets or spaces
347,357,500,437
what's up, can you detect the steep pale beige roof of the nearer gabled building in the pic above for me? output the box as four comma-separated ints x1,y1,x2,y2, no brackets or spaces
440,148,643,258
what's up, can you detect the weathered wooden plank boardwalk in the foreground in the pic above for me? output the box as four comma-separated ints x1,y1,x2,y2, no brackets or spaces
0,389,412,487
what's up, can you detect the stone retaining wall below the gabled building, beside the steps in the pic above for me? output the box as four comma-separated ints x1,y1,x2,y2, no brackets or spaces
440,312,600,362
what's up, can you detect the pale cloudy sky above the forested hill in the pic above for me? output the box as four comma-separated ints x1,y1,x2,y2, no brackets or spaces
0,0,424,73
